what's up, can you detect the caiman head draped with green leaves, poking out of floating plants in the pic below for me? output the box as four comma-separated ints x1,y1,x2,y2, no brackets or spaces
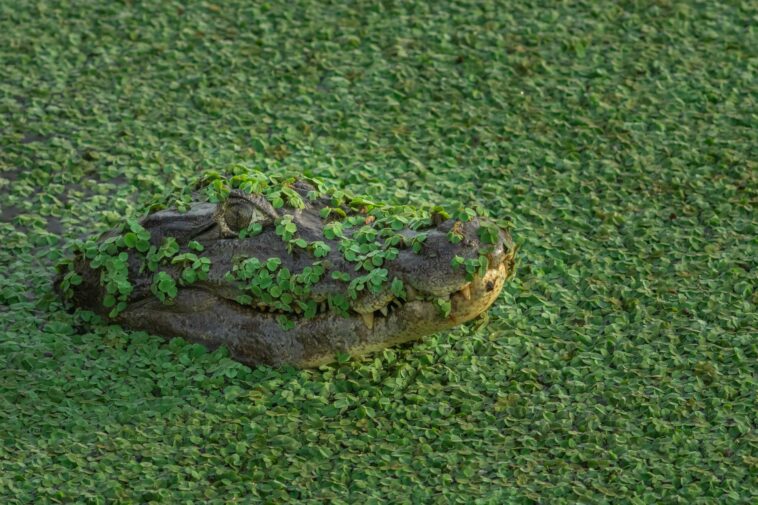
57,168,515,367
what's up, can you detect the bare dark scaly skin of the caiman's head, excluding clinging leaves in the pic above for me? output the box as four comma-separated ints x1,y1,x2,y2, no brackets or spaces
65,177,515,367
